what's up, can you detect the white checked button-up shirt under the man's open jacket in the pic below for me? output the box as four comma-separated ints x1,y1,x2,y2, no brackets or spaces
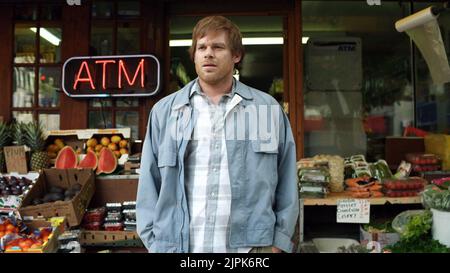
185,80,251,253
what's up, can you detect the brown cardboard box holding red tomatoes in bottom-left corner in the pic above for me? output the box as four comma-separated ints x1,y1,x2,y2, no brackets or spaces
5,219,66,253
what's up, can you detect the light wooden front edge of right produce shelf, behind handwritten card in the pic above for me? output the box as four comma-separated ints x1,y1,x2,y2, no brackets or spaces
301,193,422,206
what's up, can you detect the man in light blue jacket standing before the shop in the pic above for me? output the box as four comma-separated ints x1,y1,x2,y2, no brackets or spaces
137,16,298,253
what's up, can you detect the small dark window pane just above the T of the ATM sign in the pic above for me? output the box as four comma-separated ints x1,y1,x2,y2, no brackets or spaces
90,25,114,56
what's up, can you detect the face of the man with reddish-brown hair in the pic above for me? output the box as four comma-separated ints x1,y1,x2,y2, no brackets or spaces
194,31,241,85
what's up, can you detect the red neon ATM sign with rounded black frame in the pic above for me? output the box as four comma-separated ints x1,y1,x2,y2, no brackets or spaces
61,55,160,98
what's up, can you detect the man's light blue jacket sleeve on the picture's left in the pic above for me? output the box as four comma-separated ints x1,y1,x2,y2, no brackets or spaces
136,109,161,252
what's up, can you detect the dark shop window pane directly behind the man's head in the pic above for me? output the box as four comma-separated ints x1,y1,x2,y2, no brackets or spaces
169,16,284,103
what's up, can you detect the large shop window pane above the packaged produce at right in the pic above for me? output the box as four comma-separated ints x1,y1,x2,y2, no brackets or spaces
302,1,414,161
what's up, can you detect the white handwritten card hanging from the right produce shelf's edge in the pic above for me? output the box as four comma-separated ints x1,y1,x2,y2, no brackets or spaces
336,199,370,224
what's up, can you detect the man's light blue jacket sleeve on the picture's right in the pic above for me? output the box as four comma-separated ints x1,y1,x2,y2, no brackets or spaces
273,107,299,252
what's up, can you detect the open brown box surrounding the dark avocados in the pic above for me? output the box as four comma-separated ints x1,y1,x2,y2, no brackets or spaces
19,169,95,226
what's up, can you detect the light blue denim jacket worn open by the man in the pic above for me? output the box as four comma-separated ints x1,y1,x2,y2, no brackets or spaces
136,78,299,252
